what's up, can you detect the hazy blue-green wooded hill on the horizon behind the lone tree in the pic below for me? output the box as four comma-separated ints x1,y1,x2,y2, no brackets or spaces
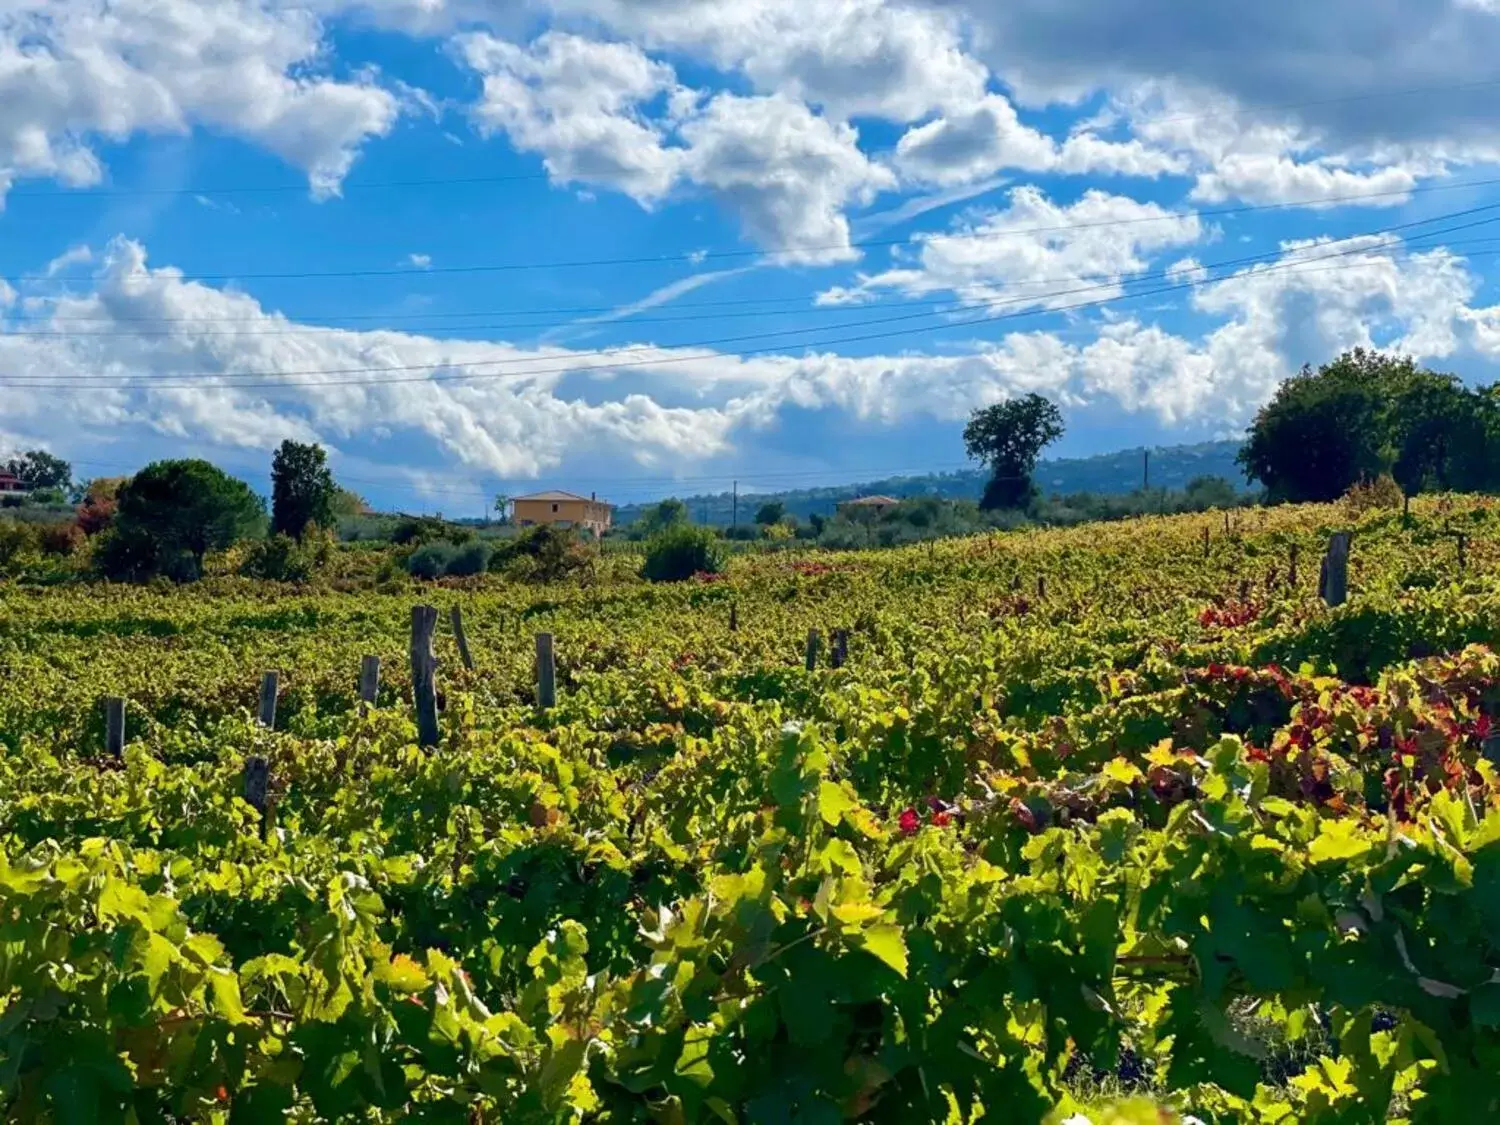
615,441,1248,527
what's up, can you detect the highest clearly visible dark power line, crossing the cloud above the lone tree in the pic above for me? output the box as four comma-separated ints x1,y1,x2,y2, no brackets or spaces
9,177,1500,284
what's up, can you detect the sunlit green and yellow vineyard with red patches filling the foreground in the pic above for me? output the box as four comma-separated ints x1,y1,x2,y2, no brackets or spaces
0,497,1500,1125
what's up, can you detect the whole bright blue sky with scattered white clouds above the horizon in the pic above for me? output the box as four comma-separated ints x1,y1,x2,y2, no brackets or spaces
0,0,1500,516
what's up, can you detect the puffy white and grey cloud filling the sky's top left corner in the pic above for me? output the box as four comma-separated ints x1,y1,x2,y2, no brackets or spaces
0,0,399,194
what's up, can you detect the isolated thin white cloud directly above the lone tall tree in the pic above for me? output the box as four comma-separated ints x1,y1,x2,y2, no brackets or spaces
824,188,1203,309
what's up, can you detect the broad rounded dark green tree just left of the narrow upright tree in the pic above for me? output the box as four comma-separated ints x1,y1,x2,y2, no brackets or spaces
105,461,266,579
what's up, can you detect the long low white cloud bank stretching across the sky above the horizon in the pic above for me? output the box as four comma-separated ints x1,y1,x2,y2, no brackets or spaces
0,231,1500,479
